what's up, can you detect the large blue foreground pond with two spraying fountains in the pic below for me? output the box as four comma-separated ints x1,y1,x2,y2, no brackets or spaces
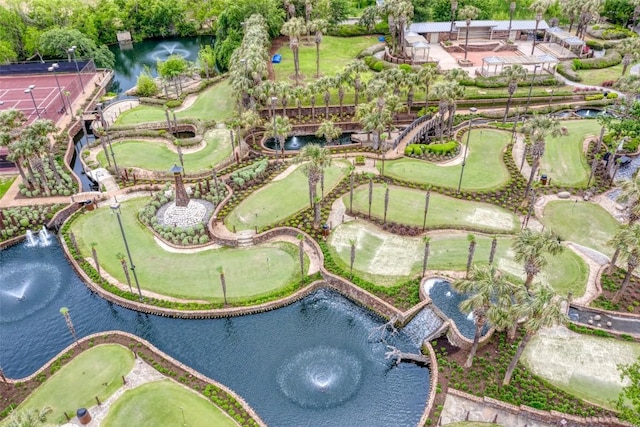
0,239,429,426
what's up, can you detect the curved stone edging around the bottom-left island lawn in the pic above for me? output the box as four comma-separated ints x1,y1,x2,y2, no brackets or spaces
1,331,267,427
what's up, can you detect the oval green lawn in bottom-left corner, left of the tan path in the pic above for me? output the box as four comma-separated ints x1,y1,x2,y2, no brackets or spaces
18,344,134,425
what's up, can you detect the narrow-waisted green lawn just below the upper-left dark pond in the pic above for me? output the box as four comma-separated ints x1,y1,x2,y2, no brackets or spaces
115,80,235,125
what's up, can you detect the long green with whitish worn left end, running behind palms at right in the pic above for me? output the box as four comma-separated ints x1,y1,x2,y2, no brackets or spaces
329,221,588,296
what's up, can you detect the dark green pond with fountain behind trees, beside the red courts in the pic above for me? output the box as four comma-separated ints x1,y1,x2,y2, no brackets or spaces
109,36,214,95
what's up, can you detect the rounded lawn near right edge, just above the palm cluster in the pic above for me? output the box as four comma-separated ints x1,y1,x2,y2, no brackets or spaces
542,200,620,256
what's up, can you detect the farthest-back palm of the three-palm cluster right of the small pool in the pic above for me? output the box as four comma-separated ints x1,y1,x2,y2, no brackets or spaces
511,228,564,289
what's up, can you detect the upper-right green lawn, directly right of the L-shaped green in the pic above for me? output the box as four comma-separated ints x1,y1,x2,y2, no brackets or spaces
540,120,600,187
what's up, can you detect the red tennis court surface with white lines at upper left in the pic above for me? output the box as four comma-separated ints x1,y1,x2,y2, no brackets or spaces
0,73,95,123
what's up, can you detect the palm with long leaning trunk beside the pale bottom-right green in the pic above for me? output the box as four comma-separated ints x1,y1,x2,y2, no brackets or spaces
502,284,568,385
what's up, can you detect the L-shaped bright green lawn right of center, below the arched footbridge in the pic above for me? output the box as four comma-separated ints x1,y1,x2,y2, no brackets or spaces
378,129,511,191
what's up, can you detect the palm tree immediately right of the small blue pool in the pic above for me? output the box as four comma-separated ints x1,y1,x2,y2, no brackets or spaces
451,265,515,368
